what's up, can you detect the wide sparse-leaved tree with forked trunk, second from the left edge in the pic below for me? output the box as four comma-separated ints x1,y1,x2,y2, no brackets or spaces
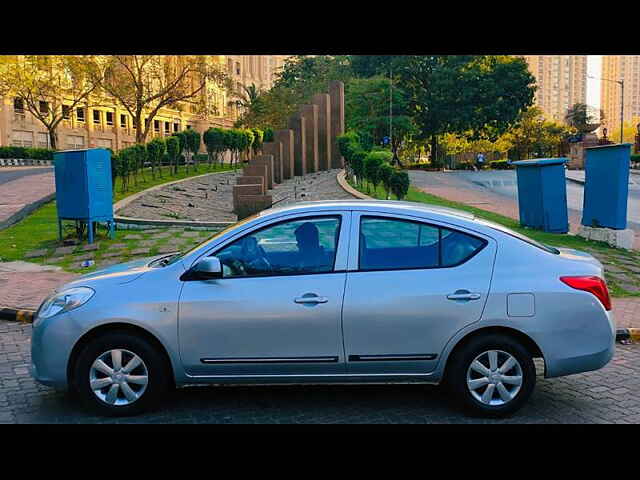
84,55,226,143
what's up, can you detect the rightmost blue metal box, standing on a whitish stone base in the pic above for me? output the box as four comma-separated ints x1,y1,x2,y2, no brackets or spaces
582,143,631,230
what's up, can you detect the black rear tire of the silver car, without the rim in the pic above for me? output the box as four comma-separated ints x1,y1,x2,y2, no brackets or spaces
445,334,536,418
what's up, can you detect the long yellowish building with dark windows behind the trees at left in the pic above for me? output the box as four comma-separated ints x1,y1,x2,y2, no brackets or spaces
0,55,286,150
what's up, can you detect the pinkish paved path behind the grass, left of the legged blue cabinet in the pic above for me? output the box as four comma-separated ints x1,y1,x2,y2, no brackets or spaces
0,170,56,229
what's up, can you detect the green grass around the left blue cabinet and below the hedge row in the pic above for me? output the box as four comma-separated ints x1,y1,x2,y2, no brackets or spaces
0,165,230,272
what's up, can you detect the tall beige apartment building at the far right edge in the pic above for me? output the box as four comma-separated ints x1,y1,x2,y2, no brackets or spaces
600,55,640,131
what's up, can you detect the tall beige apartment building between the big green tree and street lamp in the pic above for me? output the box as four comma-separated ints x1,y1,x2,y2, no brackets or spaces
524,55,587,122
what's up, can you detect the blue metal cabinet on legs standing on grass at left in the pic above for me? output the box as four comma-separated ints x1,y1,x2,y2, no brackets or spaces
53,148,113,243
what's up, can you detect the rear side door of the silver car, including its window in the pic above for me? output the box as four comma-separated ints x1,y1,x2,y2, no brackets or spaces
343,212,496,374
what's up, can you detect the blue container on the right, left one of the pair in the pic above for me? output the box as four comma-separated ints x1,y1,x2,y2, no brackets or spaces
512,158,569,233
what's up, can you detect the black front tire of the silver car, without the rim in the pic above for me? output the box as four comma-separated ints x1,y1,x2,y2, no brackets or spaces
73,331,172,417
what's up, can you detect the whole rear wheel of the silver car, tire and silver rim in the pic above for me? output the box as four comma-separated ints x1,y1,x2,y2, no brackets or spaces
447,334,536,417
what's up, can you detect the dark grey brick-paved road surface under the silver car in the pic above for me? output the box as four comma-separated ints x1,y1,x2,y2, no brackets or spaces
0,321,640,423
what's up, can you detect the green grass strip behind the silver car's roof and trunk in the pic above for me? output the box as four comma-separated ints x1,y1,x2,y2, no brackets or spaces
350,176,640,297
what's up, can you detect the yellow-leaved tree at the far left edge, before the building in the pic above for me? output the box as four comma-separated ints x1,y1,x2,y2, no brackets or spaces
0,55,97,149
